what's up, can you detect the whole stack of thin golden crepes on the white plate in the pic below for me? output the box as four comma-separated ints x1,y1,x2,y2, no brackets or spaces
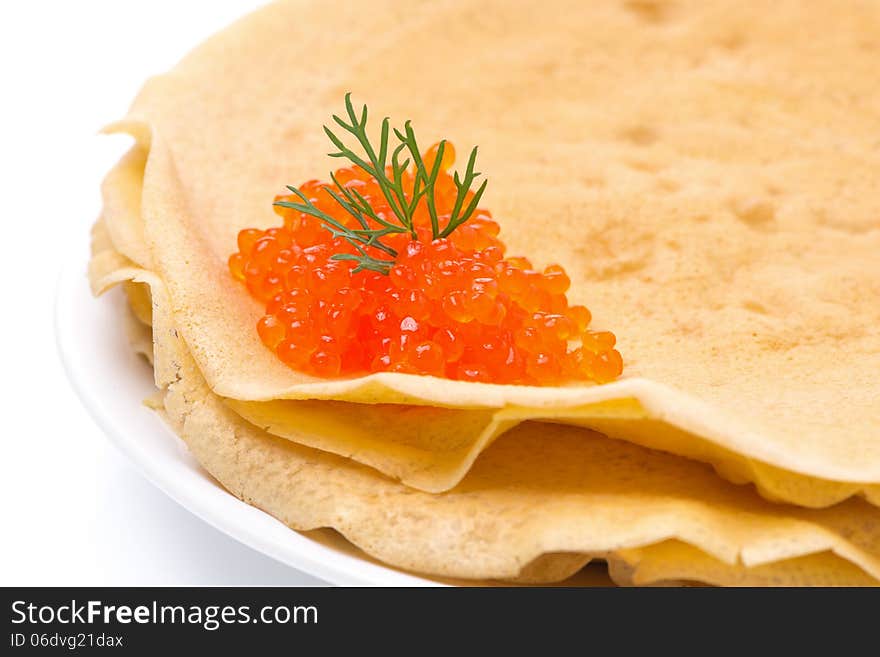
90,0,880,585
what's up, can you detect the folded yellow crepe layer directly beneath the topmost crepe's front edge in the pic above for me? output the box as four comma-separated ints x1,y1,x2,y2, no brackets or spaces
226,392,880,508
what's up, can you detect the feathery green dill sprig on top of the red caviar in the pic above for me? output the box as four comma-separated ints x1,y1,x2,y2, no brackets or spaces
275,93,488,274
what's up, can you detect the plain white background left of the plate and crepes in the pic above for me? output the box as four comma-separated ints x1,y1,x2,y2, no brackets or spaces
0,0,320,585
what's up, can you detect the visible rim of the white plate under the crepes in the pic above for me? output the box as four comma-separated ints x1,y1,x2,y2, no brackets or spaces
55,255,439,586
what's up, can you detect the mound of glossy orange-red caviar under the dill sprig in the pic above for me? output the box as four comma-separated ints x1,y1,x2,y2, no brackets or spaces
229,143,623,385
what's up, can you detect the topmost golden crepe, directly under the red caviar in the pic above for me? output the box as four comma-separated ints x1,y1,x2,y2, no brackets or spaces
113,2,880,498
